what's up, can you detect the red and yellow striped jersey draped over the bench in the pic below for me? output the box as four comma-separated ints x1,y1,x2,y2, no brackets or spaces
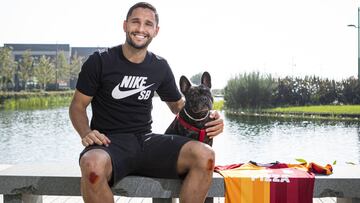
215,162,315,203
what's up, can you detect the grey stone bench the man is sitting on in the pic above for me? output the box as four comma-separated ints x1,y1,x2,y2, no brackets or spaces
0,164,360,199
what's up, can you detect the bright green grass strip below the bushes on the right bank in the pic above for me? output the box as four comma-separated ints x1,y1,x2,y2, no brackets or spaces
265,105,360,115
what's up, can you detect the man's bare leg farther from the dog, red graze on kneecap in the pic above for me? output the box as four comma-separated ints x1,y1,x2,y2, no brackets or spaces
80,149,114,203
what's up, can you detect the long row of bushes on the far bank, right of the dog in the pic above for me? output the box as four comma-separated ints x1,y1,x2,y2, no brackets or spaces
224,72,360,109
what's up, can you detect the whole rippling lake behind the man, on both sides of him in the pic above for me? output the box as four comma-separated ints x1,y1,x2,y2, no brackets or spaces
0,98,360,165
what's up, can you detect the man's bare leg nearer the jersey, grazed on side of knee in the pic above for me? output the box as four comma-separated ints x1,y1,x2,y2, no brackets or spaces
177,141,215,203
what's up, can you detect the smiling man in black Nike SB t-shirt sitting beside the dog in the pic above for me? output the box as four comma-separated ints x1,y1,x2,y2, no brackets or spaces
69,2,223,203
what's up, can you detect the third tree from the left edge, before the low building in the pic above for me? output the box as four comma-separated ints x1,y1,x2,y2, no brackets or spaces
35,56,55,90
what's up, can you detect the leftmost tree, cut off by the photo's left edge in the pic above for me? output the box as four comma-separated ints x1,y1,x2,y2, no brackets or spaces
0,47,16,90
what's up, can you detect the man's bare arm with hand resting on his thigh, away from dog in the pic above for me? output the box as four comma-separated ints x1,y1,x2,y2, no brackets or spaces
69,90,110,147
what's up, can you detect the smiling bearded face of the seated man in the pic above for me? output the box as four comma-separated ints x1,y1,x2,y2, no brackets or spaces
124,8,159,49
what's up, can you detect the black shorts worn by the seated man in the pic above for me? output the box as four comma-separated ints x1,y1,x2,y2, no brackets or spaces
80,133,191,186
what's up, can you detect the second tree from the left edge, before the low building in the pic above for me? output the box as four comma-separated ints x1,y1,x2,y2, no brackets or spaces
19,50,34,90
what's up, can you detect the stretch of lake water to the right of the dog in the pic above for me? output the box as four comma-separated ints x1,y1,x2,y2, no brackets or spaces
218,116,360,164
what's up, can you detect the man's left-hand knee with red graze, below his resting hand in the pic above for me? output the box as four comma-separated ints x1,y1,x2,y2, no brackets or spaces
80,149,112,184
